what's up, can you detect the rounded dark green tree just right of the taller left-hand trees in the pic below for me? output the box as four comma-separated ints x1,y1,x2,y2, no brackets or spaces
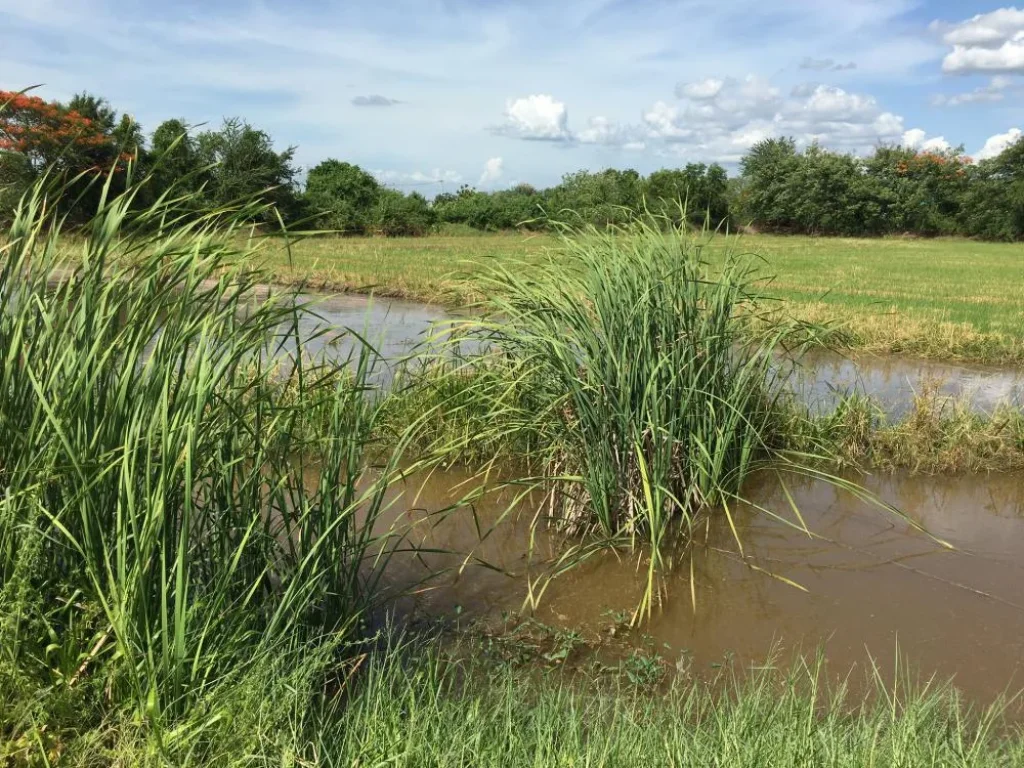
305,160,385,234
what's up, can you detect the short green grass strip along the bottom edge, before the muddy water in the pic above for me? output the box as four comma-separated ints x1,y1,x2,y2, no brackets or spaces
9,647,1024,768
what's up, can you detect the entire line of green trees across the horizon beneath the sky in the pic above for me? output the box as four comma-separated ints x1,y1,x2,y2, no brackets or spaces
0,91,1024,241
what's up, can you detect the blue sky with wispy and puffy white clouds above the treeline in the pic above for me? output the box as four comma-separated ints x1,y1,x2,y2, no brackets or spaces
0,0,1024,196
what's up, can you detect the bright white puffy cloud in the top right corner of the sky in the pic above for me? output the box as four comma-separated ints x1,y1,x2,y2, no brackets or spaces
931,7,1024,74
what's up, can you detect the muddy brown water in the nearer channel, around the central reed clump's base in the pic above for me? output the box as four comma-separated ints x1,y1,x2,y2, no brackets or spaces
372,466,1024,701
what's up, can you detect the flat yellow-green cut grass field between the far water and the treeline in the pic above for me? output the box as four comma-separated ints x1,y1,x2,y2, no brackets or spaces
258,234,1024,364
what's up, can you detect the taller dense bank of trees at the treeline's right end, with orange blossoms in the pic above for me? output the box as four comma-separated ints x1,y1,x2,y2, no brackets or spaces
730,138,1024,241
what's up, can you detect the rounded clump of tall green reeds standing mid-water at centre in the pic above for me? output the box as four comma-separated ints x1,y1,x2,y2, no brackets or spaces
442,220,847,618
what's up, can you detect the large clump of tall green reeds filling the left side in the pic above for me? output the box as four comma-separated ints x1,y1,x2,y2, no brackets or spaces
0,173,419,751
